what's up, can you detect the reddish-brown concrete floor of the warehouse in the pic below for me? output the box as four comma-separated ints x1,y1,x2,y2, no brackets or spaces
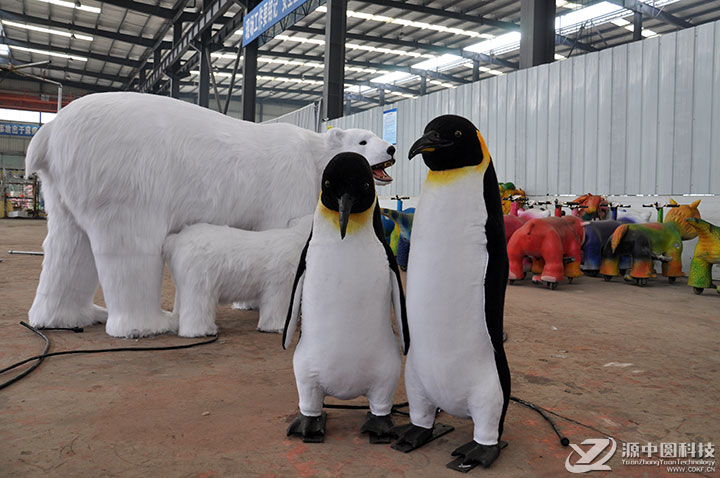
0,220,720,477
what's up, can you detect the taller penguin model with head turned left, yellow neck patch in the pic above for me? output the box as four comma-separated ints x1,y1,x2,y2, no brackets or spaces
393,115,510,471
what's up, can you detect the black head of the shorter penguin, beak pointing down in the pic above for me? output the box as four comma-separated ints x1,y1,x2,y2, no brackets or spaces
320,153,375,239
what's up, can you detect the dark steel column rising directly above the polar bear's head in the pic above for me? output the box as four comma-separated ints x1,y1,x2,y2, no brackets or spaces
323,0,347,119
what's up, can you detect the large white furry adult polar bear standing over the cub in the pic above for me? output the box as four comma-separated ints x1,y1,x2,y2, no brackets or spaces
26,92,395,337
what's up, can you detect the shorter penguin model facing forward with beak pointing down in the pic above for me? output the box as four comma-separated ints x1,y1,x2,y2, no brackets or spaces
283,153,410,443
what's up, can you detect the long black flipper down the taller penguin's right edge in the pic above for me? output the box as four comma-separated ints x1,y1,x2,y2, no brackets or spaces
483,161,510,440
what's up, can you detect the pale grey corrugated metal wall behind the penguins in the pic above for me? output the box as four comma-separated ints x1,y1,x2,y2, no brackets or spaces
329,18,720,196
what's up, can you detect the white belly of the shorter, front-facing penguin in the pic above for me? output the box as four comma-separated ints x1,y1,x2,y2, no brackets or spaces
294,230,401,408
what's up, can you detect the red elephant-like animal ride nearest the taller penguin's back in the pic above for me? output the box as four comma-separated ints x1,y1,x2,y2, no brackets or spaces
507,216,585,290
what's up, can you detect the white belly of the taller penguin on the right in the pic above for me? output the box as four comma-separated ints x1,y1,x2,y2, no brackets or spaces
406,172,503,422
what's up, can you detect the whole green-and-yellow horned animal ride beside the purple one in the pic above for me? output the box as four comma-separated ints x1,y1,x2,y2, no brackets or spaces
600,199,700,287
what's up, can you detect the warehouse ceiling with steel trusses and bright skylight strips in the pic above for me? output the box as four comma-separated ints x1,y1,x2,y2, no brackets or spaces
0,0,720,108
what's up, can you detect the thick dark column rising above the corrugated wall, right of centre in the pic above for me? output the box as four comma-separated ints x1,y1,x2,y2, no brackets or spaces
520,0,555,68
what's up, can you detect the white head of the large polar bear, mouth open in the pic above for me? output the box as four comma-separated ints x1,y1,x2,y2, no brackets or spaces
323,128,395,186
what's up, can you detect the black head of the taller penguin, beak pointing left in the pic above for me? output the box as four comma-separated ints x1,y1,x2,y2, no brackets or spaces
408,115,485,171
